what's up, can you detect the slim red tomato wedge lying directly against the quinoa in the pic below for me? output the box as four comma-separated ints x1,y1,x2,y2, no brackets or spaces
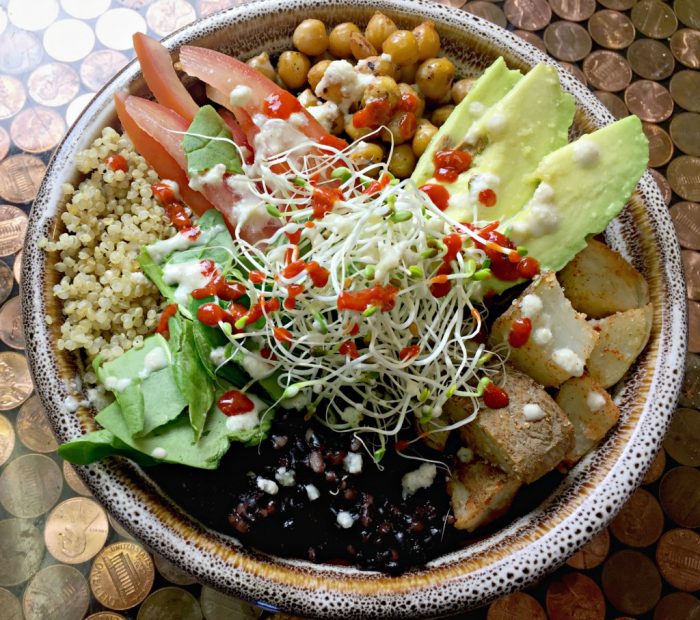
114,93,214,215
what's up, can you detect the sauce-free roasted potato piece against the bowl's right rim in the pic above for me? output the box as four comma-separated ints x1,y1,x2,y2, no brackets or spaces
586,304,653,388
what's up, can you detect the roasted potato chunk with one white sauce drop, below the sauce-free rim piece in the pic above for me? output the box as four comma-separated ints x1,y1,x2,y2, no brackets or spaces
556,373,620,465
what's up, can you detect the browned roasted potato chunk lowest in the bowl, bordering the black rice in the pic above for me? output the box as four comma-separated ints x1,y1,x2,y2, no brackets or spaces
447,460,522,532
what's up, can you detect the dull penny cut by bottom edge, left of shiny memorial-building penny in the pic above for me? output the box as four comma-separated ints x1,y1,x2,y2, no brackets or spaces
22,564,90,620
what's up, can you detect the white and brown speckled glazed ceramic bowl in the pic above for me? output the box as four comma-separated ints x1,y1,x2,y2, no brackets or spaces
22,0,686,618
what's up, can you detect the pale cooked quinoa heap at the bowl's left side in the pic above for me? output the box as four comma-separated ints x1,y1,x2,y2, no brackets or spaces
43,127,175,362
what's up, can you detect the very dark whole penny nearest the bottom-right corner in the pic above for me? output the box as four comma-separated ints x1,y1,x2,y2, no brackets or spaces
602,549,661,615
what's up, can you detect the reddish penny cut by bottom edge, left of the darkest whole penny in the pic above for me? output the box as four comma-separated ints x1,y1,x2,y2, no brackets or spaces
546,573,605,620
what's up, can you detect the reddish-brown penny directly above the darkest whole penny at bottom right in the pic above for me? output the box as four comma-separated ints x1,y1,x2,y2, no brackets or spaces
610,489,664,547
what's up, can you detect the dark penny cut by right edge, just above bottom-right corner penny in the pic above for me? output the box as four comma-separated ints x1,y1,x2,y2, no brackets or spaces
656,529,700,592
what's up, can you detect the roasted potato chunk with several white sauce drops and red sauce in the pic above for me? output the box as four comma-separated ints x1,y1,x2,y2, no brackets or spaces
491,273,598,387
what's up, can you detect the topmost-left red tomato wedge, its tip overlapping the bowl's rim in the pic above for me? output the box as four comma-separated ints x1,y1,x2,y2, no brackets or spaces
133,32,199,123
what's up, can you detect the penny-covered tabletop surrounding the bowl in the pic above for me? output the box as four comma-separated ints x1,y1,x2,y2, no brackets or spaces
0,0,700,620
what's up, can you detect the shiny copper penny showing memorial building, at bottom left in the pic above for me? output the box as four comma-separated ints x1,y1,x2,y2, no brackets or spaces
90,542,155,611
